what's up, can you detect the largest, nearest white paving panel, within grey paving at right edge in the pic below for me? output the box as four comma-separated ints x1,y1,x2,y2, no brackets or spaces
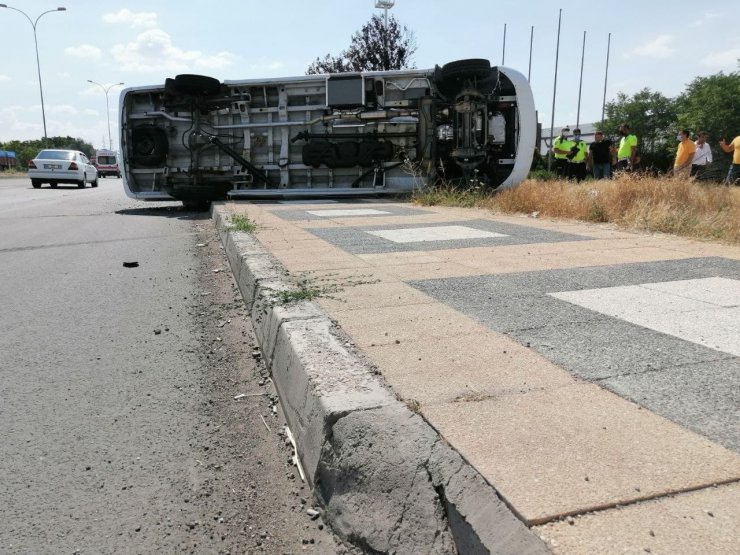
550,278,740,356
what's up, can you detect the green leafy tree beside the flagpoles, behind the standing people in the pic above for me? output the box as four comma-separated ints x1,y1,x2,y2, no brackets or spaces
596,88,678,170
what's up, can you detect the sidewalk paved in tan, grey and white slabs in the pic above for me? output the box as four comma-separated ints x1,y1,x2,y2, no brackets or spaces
217,201,740,553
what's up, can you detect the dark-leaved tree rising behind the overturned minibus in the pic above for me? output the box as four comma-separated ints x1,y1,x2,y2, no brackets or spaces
306,15,416,75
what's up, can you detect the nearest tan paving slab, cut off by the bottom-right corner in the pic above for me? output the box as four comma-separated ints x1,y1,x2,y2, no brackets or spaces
535,483,740,555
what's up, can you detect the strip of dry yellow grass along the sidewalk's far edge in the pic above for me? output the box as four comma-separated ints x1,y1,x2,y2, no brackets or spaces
414,175,740,244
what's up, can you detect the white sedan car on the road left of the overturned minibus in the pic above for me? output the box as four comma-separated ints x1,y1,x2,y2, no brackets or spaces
28,149,98,189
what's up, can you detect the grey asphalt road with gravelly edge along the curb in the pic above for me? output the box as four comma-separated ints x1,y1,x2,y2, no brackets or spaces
0,179,342,554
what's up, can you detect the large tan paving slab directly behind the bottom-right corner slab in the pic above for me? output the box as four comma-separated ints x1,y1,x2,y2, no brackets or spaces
422,384,740,524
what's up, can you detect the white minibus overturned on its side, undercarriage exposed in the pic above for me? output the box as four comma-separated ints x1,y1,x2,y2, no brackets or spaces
119,59,537,202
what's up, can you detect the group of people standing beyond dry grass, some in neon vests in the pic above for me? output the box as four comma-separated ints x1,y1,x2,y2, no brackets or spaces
552,123,740,184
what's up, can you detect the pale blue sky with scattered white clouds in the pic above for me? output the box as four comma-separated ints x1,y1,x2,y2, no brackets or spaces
0,0,740,152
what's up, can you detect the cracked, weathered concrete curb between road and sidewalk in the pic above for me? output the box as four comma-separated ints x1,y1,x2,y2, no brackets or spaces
212,203,549,554
